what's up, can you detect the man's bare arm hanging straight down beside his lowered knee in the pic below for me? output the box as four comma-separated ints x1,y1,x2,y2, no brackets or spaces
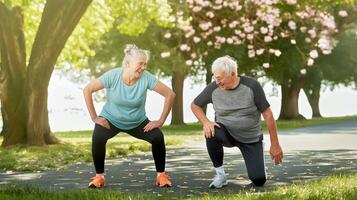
262,108,283,165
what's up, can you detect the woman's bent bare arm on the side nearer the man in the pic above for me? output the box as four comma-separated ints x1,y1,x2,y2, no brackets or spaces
144,81,176,132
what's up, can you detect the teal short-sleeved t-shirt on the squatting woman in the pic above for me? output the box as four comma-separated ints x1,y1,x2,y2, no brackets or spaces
99,68,159,130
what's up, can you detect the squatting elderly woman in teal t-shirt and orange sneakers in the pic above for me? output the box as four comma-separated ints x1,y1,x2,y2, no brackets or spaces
83,45,175,188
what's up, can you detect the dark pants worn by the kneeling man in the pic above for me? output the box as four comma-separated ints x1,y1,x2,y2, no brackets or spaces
206,124,266,186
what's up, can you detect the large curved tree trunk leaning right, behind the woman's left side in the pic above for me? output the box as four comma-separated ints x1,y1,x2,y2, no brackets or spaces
27,0,91,145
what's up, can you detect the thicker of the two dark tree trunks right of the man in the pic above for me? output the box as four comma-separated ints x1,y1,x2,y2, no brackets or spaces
279,79,304,120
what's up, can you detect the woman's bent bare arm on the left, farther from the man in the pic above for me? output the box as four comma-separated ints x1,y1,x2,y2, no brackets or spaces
83,79,110,129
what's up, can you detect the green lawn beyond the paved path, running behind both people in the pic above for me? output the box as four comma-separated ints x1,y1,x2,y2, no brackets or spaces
0,116,357,171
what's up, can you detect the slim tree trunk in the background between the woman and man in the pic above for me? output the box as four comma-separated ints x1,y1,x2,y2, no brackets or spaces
171,71,185,124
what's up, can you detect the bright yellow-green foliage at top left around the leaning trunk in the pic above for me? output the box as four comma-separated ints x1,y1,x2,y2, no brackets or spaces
1,0,170,71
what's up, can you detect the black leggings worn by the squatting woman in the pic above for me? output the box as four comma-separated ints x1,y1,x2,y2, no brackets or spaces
92,119,166,174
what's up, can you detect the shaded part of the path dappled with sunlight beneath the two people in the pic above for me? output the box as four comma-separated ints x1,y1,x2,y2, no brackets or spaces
0,142,357,197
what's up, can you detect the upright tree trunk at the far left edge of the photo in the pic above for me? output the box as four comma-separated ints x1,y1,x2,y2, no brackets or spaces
0,2,27,146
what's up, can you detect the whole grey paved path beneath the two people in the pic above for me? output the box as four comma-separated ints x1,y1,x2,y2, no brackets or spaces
0,121,357,197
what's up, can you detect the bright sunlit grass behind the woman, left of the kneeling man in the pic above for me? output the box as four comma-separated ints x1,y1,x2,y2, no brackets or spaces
0,131,201,171
